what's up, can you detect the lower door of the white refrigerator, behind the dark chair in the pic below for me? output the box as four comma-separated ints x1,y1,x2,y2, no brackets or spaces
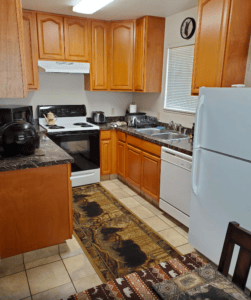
189,149,251,288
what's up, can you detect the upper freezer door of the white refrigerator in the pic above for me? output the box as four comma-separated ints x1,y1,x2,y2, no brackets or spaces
194,88,251,161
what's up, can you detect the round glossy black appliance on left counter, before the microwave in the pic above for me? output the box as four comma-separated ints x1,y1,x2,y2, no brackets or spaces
0,121,40,157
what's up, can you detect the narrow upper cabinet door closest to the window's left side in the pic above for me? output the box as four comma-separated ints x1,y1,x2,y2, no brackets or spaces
134,18,146,91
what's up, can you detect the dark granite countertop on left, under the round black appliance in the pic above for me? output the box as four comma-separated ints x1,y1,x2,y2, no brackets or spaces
0,134,74,172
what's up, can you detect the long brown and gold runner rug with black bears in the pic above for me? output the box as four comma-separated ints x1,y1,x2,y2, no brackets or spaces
73,184,180,282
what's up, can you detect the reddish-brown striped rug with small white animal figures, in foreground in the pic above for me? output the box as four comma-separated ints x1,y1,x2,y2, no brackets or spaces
67,253,206,300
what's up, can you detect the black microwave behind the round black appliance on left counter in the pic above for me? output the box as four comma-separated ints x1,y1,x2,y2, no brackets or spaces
0,105,33,127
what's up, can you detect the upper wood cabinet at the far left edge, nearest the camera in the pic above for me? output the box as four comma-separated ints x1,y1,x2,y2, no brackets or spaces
0,0,28,98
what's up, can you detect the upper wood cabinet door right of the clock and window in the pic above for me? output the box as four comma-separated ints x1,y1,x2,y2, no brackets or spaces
192,0,231,94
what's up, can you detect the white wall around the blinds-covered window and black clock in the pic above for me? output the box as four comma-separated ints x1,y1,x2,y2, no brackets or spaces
133,7,251,128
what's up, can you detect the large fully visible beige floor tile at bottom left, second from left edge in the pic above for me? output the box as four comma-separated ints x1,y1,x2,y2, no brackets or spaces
27,261,71,295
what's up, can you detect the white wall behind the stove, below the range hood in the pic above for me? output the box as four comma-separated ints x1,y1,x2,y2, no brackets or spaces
0,73,132,117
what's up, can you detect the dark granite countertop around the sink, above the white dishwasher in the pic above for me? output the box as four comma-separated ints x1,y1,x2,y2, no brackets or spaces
99,123,193,156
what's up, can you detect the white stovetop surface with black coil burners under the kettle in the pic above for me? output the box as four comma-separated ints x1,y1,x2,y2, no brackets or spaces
39,117,99,132
